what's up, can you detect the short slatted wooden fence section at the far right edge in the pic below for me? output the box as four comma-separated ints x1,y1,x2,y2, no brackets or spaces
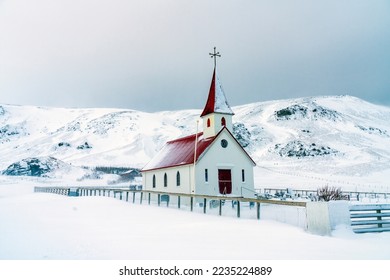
349,204,390,233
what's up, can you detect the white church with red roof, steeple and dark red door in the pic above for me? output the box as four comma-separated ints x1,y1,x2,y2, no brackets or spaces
141,48,256,200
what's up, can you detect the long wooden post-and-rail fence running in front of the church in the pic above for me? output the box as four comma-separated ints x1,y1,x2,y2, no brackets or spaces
34,187,306,219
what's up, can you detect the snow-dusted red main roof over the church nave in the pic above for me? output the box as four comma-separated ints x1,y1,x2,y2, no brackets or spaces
142,132,215,171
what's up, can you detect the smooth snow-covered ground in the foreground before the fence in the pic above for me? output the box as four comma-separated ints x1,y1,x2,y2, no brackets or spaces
0,176,390,260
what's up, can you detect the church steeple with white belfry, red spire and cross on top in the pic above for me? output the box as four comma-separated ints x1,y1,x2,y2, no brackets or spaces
200,48,234,138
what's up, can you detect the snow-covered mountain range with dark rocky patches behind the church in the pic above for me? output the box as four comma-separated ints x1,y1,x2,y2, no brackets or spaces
0,96,390,188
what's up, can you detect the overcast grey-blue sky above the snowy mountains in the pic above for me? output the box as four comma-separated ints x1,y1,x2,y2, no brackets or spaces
0,0,390,112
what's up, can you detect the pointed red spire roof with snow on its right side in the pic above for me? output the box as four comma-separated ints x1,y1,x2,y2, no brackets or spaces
200,67,234,117
